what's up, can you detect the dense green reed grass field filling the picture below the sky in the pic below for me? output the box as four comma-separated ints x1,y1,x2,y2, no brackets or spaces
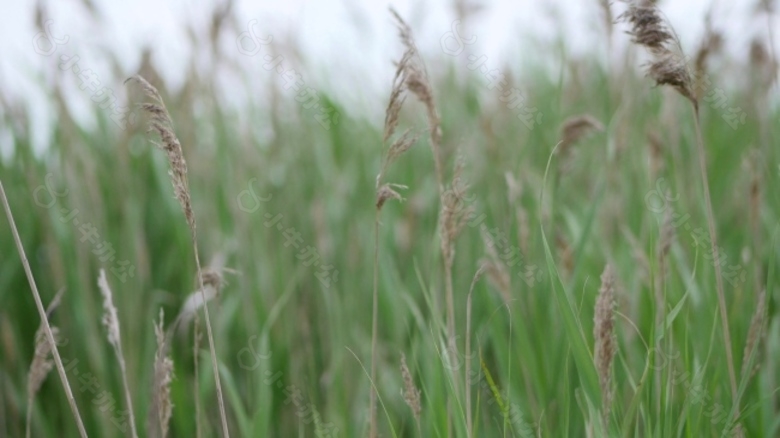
0,1,780,437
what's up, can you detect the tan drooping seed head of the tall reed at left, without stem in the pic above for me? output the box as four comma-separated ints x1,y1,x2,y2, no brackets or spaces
125,75,195,233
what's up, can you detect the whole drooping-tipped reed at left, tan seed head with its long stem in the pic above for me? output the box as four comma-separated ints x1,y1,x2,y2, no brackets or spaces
125,75,230,438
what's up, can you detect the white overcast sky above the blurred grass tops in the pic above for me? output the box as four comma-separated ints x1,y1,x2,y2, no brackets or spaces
0,0,780,157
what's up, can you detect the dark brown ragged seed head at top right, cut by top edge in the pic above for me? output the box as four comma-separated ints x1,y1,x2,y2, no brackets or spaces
618,0,697,104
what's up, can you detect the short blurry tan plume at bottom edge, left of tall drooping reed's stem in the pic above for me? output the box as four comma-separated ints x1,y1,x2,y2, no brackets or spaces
147,308,173,438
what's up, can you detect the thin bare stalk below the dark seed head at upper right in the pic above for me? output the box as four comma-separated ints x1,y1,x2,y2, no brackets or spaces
691,100,737,402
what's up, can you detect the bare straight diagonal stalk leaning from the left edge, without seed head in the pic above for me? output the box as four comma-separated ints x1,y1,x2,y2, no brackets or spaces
0,181,87,438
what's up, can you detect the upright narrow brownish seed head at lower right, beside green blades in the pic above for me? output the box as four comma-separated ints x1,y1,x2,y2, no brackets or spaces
593,265,617,424
